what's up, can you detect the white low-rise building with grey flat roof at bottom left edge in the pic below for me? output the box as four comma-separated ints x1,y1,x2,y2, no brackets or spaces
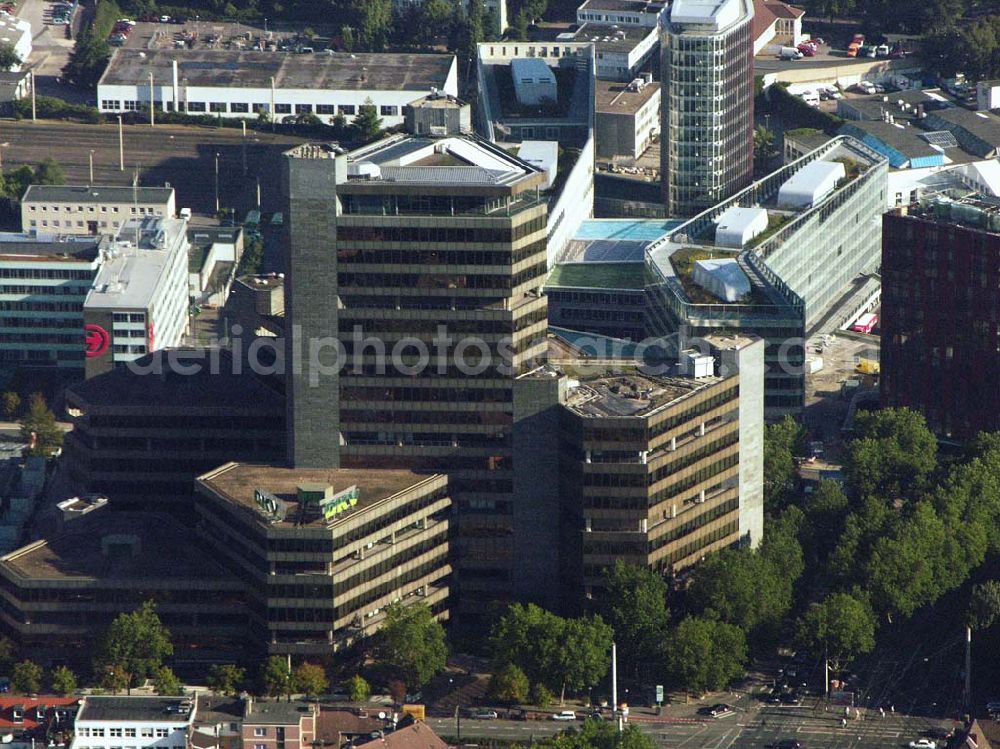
70,696,195,749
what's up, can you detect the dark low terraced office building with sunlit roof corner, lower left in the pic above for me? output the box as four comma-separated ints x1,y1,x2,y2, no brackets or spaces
0,505,248,664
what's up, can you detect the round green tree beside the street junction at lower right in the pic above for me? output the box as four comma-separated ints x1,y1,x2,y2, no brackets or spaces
797,593,875,670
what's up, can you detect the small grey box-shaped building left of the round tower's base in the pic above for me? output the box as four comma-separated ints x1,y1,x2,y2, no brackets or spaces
594,78,660,159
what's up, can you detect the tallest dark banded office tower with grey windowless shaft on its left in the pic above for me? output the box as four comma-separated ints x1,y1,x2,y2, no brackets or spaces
285,136,559,606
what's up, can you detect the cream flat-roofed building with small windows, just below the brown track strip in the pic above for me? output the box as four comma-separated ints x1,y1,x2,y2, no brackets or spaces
21,185,177,235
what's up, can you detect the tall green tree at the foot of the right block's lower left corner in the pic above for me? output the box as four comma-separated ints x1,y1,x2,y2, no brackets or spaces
598,560,670,676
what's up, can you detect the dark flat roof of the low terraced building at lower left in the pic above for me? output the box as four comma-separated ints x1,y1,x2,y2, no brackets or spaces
0,510,232,582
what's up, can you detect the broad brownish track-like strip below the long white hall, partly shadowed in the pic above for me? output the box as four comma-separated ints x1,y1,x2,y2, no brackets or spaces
0,120,303,213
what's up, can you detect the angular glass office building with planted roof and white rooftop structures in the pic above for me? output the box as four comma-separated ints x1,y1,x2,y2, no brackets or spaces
645,136,888,418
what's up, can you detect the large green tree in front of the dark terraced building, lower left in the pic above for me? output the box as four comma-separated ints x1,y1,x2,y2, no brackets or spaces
95,601,174,694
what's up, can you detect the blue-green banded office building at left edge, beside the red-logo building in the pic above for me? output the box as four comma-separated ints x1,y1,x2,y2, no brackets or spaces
0,234,109,376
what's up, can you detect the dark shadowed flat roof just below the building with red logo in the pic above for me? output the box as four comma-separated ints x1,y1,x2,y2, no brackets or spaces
67,349,284,414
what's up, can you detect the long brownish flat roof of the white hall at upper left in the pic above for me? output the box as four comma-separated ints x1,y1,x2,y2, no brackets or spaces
100,48,455,92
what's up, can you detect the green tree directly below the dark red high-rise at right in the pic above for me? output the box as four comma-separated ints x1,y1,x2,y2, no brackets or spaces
844,408,937,500
